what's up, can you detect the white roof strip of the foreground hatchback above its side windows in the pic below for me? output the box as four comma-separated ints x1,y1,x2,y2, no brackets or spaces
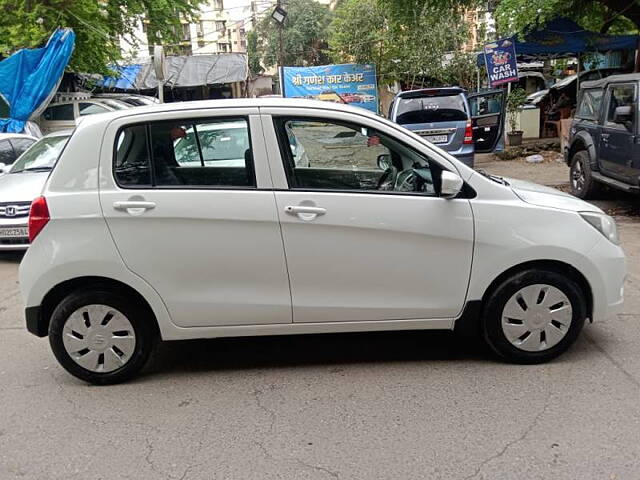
72,98,382,128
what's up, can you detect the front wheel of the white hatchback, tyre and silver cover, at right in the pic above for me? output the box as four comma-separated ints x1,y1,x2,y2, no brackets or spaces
483,269,587,364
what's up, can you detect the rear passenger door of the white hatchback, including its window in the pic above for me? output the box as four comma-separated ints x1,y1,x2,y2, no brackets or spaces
100,112,292,327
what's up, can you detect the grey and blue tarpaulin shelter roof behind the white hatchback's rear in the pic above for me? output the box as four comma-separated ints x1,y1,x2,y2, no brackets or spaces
98,53,249,91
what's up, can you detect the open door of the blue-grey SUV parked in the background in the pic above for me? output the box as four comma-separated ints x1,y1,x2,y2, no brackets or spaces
467,90,504,153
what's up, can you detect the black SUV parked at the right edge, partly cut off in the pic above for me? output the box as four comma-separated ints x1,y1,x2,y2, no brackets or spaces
564,73,640,198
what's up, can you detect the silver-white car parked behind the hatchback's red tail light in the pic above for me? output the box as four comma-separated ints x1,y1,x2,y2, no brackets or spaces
0,132,71,250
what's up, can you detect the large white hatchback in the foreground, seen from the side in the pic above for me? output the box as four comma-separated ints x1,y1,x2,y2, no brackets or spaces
20,99,625,384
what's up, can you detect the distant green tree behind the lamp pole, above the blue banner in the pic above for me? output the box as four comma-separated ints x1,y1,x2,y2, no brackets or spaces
256,0,332,67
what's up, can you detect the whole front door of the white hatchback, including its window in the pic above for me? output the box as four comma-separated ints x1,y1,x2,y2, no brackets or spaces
274,116,473,322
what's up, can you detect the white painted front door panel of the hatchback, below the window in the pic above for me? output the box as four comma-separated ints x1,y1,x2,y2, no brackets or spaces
276,191,473,322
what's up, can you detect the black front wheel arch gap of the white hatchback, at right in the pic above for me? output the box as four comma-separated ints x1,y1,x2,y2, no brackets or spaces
454,260,593,336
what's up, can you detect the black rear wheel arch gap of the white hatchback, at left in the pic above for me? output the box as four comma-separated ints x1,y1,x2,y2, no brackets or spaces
39,276,160,335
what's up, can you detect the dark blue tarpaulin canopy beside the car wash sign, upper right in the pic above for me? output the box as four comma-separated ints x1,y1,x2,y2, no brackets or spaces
478,18,639,65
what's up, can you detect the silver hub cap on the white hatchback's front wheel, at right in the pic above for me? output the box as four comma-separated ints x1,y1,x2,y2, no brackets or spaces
502,284,573,352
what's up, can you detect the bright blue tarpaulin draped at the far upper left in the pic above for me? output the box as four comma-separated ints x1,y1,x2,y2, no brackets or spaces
0,29,76,133
